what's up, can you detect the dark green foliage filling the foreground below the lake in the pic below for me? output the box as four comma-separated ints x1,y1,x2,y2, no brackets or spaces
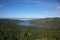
0,20,60,40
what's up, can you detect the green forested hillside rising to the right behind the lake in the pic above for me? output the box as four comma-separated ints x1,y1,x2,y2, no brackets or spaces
29,18,60,28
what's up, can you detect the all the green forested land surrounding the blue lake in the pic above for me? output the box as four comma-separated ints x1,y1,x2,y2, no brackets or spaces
0,18,60,40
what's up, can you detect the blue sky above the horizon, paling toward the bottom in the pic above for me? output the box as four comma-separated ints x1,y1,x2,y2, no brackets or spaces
0,0,60,18
